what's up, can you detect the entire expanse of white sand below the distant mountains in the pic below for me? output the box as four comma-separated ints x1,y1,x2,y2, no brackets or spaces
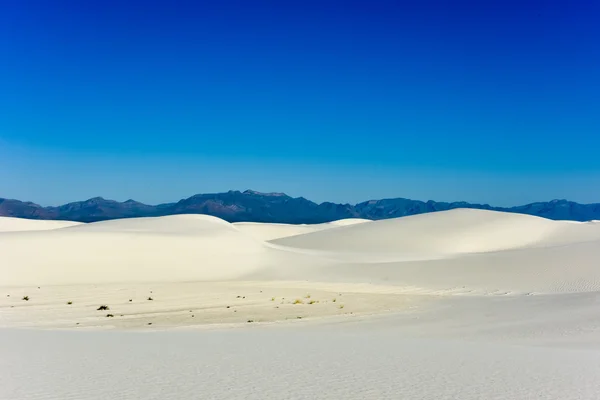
0,210,600,399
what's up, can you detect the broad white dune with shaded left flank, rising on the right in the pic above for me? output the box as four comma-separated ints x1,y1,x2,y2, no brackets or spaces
274,209,600,255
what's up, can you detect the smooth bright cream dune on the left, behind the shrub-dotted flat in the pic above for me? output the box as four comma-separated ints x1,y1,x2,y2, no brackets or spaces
0,215,298,286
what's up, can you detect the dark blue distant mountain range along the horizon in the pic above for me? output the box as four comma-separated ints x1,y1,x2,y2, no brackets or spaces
0,190,600,224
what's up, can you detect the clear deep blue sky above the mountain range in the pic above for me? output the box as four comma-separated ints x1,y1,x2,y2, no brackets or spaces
0,0,600,205
